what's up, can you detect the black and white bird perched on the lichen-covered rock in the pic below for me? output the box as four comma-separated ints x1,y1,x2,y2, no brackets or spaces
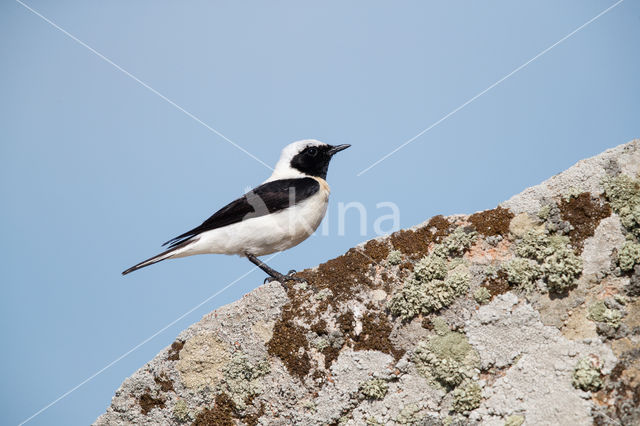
122,140,351,285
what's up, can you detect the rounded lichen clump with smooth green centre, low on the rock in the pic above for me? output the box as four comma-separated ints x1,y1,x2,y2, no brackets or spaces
412,331,479,388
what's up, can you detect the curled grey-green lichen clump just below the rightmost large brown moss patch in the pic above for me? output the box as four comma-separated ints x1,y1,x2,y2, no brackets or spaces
507,230,582,293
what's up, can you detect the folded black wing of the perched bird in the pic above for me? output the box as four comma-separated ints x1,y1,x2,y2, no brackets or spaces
163,178,320,248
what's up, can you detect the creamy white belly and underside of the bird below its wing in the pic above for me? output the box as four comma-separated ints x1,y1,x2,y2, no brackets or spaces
179,183,329,257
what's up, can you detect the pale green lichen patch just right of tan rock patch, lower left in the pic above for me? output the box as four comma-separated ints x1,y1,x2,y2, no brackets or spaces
221,352,270,410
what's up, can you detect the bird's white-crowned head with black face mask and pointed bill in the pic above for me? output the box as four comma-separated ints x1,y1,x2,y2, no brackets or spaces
270,139,351,180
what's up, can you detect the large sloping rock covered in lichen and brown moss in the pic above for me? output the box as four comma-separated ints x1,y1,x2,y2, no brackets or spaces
96,140,640,426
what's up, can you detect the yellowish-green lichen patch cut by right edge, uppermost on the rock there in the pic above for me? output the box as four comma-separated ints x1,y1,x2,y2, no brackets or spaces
602,174,640,237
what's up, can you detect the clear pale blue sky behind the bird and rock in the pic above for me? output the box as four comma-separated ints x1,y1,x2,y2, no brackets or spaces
0,0,640,425
